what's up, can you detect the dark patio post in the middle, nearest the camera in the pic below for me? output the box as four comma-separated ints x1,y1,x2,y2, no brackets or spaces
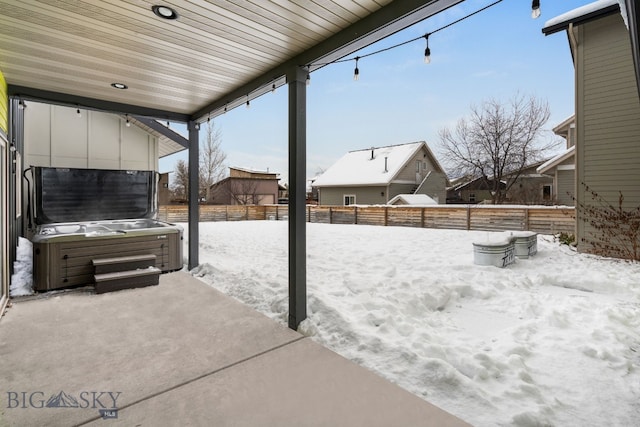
287,67,307,330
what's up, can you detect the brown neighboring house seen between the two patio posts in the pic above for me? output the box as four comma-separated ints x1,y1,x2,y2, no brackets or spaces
207,167,280,205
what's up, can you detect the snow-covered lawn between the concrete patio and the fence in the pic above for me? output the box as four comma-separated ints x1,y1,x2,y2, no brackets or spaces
183,221,640,426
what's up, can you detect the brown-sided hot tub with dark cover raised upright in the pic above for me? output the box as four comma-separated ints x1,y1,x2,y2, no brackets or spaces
31,168,183,291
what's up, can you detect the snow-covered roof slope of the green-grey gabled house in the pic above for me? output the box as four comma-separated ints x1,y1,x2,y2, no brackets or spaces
313,141,429,187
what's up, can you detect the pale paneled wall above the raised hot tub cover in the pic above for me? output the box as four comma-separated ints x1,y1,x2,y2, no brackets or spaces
24,102,158,170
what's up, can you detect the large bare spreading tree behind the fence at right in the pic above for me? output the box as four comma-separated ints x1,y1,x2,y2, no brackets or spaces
439,94,557,204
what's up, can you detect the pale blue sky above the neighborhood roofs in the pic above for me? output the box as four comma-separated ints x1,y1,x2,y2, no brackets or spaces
160,0,591,183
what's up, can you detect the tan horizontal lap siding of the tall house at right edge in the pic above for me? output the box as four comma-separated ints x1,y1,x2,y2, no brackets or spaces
576,13,640,250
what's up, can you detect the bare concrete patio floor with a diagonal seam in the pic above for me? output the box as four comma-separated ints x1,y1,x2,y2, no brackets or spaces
0,272,467,427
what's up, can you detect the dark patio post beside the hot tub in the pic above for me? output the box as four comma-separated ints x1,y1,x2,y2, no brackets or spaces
187,121,200,270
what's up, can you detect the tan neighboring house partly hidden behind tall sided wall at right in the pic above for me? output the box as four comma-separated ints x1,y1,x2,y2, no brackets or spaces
538,116,576,206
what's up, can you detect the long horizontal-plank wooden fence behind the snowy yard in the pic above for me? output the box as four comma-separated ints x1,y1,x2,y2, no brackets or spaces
159,205,576,234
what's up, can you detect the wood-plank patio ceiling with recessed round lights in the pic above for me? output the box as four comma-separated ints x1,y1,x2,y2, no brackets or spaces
0,0,463,122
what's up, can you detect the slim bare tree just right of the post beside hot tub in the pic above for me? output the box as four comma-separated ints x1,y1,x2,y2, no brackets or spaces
199,120,227,200
